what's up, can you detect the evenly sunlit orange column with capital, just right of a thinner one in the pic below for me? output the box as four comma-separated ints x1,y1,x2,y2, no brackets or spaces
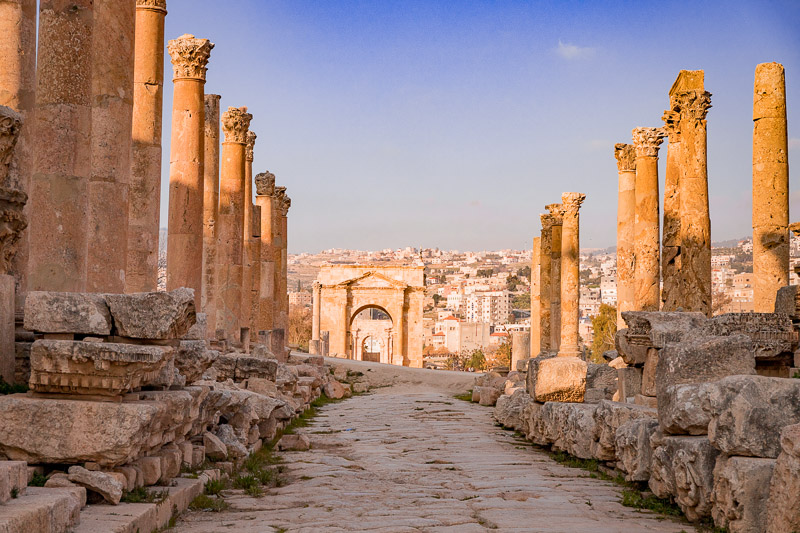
633,128,666,311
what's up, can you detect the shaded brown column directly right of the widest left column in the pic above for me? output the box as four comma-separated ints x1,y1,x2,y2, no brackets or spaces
86,0,136,294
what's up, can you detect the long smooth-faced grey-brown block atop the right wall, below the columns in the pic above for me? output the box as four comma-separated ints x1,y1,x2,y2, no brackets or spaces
656,334,756,401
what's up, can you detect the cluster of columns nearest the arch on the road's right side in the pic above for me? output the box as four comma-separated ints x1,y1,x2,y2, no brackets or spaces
530,192,586,357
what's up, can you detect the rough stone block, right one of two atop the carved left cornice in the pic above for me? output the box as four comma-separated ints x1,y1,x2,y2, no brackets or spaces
105,287,196,339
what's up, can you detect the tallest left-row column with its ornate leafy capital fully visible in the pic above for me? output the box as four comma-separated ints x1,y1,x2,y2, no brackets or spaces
167,35,214,302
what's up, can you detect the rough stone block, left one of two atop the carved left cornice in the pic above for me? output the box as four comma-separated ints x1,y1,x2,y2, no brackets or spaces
24,291,112,335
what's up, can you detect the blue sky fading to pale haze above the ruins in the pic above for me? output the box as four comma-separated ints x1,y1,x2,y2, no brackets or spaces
161,0,800,252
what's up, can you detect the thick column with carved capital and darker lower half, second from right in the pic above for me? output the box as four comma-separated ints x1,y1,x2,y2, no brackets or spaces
673,90,712,316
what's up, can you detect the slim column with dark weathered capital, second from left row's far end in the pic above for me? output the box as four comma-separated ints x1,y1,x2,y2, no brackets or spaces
255,172,275,334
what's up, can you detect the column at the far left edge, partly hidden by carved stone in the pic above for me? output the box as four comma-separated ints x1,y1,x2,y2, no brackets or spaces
0,0,36,308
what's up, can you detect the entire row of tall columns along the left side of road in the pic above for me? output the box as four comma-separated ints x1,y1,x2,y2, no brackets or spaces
0,0,291,352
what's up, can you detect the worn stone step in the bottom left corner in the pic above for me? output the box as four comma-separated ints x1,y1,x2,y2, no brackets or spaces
0,487,86,533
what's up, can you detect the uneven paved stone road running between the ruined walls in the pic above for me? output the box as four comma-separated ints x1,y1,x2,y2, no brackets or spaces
177,388,692,533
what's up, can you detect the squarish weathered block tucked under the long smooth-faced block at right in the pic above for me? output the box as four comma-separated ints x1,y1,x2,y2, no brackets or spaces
658,382,716,435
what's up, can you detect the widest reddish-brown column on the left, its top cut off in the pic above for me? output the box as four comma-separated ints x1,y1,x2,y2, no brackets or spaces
28,0,94,292
